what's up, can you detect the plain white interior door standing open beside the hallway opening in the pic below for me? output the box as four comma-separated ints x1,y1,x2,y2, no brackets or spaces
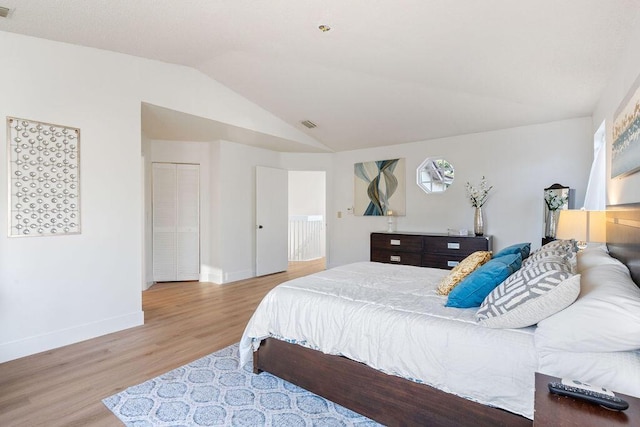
256,166,289,276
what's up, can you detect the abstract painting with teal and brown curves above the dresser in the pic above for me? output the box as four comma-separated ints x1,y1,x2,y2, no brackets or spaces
353,159,407,216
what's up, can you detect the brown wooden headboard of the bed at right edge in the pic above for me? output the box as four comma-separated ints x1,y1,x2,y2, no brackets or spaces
607,203,640,286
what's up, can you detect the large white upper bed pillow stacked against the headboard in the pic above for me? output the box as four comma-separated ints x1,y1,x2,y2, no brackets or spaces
535,264,640,352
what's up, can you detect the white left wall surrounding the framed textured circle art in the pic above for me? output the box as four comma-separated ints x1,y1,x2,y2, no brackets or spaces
0,33,143,362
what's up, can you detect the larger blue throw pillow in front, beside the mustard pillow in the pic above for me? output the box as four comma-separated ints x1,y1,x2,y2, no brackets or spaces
445,253,522,308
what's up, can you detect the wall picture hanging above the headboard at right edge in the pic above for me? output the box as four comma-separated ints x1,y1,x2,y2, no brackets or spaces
611,78,640,178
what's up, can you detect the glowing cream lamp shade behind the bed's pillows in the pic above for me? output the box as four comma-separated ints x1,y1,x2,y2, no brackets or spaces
556,209,607,242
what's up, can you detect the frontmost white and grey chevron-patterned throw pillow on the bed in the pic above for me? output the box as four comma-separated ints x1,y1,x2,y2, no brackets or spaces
477,257,580,328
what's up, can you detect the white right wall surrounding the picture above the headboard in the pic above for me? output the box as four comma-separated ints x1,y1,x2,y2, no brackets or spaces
593,21,640,205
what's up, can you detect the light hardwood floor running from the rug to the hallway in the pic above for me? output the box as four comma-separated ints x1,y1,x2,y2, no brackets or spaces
0,259,325,426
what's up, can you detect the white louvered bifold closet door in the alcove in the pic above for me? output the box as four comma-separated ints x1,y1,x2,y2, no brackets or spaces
152,163,200,282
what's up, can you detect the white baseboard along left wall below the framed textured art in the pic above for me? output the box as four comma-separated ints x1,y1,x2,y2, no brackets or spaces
0,310,144,363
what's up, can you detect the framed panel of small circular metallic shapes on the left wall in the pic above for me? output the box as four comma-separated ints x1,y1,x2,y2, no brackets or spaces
7,117,80,237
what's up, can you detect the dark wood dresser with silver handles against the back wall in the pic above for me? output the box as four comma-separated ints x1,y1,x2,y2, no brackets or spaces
371,232,492,269
